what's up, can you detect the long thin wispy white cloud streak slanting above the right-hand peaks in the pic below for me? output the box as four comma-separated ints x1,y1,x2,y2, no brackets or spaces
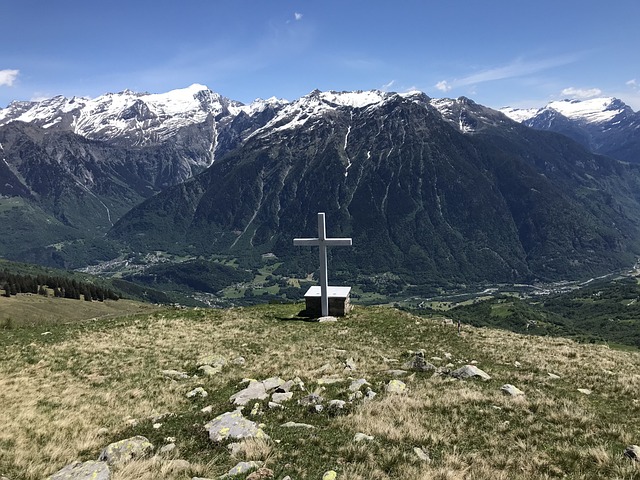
435,54,581,92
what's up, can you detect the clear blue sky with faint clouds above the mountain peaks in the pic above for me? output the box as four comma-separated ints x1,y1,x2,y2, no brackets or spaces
0,0,640,111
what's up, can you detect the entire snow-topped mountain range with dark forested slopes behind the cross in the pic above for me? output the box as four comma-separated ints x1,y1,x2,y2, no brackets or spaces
0,85,640,290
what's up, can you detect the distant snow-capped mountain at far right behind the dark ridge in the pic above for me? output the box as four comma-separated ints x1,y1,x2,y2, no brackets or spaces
500,97,640,163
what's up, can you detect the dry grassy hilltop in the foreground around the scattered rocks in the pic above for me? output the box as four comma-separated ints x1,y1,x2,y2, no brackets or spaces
0,302,640,480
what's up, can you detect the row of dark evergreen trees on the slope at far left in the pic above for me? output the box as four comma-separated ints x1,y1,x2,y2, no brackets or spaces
0,270,120,302
